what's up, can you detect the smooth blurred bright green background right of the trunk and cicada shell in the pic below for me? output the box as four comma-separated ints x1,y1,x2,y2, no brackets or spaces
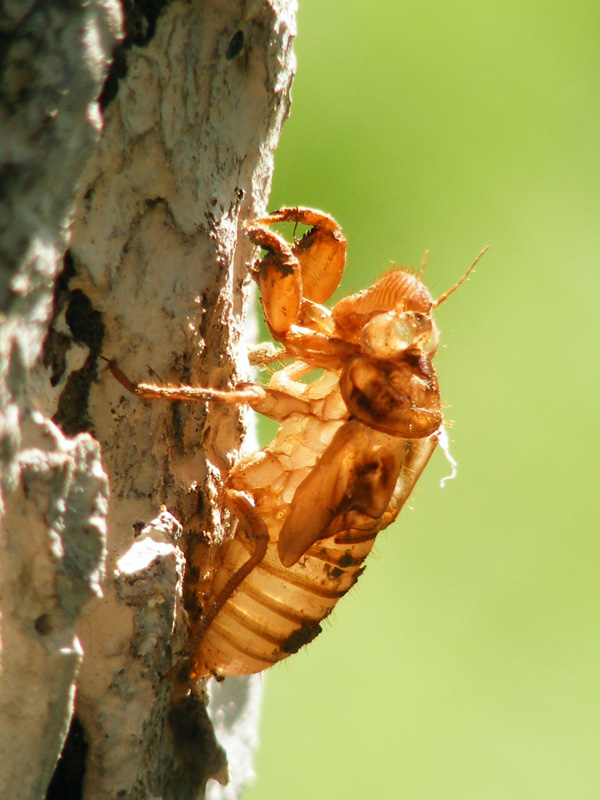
244,0,600,800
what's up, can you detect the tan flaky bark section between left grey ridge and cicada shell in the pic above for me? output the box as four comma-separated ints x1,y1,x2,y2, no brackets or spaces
30,0,295,800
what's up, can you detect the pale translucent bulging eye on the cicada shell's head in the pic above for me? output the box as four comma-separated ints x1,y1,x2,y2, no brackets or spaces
360,311,438,359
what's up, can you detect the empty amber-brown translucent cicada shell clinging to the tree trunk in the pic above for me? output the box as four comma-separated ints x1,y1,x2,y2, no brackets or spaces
111,208,486,678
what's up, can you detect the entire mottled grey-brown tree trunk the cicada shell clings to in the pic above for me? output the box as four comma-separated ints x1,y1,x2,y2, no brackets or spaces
0,0,295,800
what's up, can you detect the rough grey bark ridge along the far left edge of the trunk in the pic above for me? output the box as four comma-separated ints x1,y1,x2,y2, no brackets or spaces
0,2,120,798
